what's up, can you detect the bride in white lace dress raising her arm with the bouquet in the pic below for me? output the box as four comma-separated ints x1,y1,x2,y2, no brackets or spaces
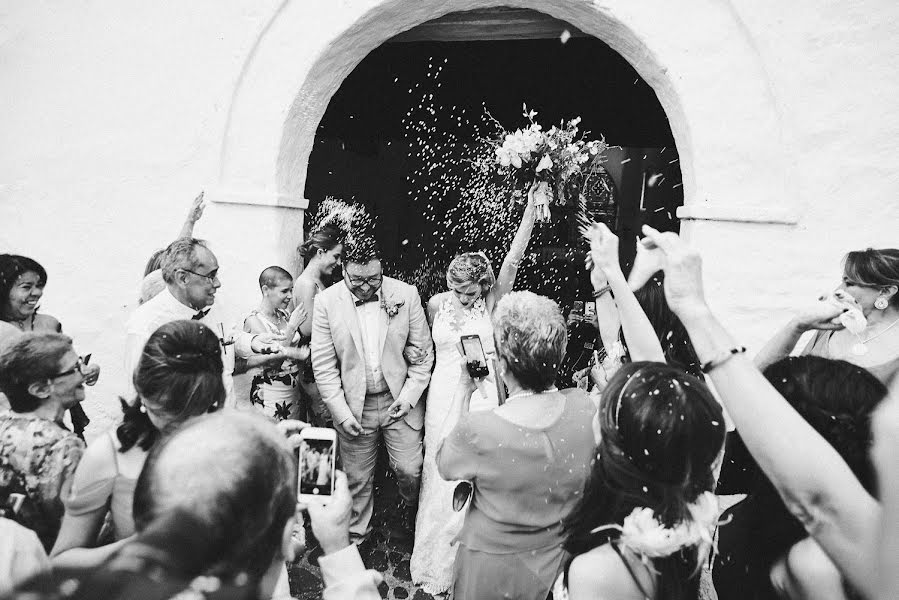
410,188,536,595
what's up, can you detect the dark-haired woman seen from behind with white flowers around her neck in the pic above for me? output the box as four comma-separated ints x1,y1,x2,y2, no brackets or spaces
553,362,726,600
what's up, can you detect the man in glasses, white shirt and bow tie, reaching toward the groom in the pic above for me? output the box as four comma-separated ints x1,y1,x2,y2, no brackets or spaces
125,238,282,407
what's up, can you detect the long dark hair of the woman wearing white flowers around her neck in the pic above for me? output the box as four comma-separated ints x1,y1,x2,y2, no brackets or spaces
564,362,725,600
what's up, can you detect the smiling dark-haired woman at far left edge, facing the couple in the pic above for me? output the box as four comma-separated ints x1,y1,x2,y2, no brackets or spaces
0,254,100,440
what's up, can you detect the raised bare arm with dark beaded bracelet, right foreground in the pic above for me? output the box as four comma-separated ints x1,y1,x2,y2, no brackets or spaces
644,227,881,591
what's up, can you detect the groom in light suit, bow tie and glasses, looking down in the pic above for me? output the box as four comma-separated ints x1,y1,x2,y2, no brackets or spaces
312,238,433,543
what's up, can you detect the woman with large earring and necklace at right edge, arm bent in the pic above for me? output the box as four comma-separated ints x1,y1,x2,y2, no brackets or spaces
755,248,899,384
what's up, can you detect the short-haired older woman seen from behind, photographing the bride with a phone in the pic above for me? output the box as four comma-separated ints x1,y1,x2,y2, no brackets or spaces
437,292,595,600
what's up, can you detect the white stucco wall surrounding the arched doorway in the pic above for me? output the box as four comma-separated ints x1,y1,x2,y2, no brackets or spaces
0,0,899,431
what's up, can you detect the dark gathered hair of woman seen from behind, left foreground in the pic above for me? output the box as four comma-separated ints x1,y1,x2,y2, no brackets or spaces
116,321,225,452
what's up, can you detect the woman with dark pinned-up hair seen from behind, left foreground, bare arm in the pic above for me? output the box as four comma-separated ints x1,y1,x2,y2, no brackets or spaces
51,321,225,567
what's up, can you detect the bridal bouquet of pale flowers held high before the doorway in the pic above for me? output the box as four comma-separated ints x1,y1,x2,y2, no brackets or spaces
482,104,608,222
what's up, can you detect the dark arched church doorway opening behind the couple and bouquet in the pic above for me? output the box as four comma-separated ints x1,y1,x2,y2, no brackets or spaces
305,8,683,310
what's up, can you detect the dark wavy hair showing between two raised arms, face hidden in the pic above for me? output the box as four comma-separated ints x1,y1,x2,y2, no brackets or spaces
634,271,702,378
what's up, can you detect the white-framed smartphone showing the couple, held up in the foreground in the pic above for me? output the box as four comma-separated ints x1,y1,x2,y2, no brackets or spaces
297,427,337,504
